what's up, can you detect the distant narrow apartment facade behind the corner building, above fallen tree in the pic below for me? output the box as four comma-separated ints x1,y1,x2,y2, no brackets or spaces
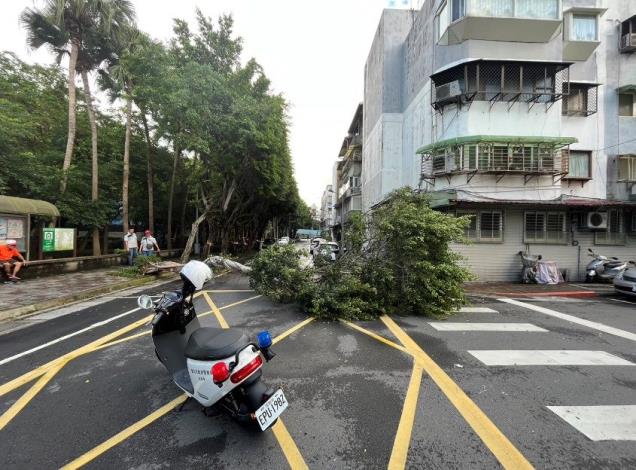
331,104,363,241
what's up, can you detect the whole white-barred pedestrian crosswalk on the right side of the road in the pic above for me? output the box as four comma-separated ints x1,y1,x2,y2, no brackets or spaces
428,307,636,441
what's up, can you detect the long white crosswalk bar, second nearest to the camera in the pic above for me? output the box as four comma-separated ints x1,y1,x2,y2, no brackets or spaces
468,349,636,366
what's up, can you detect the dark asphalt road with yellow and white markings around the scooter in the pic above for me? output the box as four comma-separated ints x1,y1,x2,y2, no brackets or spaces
0,275,636,469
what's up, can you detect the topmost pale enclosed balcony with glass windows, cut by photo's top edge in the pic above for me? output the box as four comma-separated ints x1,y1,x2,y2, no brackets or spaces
436,0,561,45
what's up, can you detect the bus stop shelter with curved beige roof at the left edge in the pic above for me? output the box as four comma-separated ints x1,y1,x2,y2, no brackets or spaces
0,196,60,260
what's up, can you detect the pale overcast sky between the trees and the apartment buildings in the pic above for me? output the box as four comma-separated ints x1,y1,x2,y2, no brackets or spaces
0,0,422,206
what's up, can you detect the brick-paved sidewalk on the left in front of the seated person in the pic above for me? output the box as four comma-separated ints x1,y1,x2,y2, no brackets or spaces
0,267,174,321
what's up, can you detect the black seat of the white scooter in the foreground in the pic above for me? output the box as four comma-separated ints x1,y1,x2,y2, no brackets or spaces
185,328,250,361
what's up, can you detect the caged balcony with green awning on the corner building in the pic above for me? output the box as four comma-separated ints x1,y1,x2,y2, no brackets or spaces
417,136,576,183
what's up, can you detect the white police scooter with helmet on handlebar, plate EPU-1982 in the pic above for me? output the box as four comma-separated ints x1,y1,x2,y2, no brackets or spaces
137,261,288,431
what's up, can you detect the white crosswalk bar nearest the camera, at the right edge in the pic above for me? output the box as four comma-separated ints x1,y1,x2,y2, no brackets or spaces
548,405,636,441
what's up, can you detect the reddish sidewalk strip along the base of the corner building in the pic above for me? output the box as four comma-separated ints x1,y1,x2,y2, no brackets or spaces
466,282,614,298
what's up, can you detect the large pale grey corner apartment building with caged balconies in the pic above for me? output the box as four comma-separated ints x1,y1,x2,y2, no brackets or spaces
362,0,636,281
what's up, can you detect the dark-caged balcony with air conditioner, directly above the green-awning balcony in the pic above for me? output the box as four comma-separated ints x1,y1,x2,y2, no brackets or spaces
431,60,571,110
